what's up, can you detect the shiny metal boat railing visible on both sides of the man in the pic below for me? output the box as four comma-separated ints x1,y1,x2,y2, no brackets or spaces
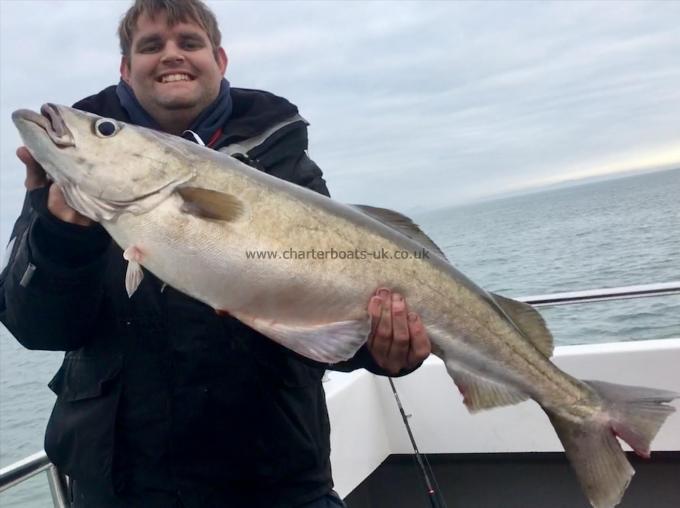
0,281,680,508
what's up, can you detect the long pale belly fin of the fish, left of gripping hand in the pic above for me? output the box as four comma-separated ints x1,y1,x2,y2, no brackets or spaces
239,314,370,363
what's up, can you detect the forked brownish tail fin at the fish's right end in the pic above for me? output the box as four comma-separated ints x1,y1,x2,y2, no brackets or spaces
544,381,680,508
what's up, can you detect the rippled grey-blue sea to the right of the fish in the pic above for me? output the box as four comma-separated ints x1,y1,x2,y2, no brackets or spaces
417,170,680,345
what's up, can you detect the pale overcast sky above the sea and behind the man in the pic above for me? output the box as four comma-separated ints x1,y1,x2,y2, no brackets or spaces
0,0,680,243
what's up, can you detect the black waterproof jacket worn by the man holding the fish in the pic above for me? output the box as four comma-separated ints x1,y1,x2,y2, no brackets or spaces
0,87,396,508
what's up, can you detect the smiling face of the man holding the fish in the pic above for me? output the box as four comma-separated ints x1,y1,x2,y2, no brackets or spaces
120,13,227,119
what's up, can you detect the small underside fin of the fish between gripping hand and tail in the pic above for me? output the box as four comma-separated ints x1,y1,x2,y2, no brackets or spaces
446,364,529,413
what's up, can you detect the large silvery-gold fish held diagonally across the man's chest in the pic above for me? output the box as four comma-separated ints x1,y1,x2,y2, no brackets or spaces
12,104,679,508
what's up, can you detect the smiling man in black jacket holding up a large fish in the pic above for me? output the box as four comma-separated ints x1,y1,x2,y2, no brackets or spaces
0,0,430,508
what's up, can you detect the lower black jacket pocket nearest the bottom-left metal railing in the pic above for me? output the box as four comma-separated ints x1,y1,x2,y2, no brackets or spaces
45,355,122,491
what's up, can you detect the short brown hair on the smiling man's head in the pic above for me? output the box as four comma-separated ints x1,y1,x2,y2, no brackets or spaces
118,0,222,59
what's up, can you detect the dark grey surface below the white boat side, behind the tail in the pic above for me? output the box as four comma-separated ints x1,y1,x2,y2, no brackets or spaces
345,452,680,508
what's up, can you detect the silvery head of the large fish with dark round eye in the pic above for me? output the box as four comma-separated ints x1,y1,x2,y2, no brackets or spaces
12,104,196,221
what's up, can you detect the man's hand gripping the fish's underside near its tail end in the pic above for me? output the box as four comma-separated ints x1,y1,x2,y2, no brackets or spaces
368,288,432,374
